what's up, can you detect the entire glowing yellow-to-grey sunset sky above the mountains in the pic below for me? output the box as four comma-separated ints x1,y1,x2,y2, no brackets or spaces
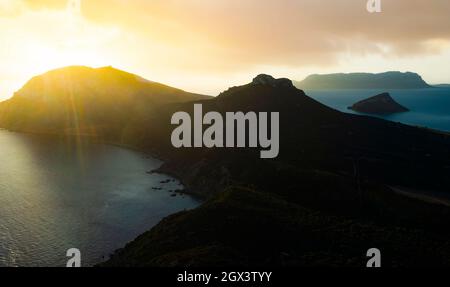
0,0,450,99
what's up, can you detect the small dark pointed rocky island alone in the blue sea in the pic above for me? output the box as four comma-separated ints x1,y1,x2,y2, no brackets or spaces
349,93,409,115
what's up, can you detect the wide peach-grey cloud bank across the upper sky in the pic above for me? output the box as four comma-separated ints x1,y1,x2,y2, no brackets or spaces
72,0,450,69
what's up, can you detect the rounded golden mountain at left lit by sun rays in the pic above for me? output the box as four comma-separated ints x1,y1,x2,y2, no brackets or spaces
0,66,206,140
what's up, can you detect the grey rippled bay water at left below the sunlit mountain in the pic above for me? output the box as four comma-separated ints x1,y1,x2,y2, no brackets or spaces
0,130,199,266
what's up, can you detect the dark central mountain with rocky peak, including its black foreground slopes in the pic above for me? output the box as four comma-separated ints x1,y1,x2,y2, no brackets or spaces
101,75,450,267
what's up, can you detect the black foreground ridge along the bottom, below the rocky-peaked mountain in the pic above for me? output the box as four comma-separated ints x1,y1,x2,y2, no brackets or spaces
103,188,450,268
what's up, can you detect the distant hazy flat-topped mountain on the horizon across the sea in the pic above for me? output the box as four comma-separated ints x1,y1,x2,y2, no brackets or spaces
296,72,430,90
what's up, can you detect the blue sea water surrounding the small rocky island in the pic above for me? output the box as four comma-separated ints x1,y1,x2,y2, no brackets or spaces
305,88,450,131
